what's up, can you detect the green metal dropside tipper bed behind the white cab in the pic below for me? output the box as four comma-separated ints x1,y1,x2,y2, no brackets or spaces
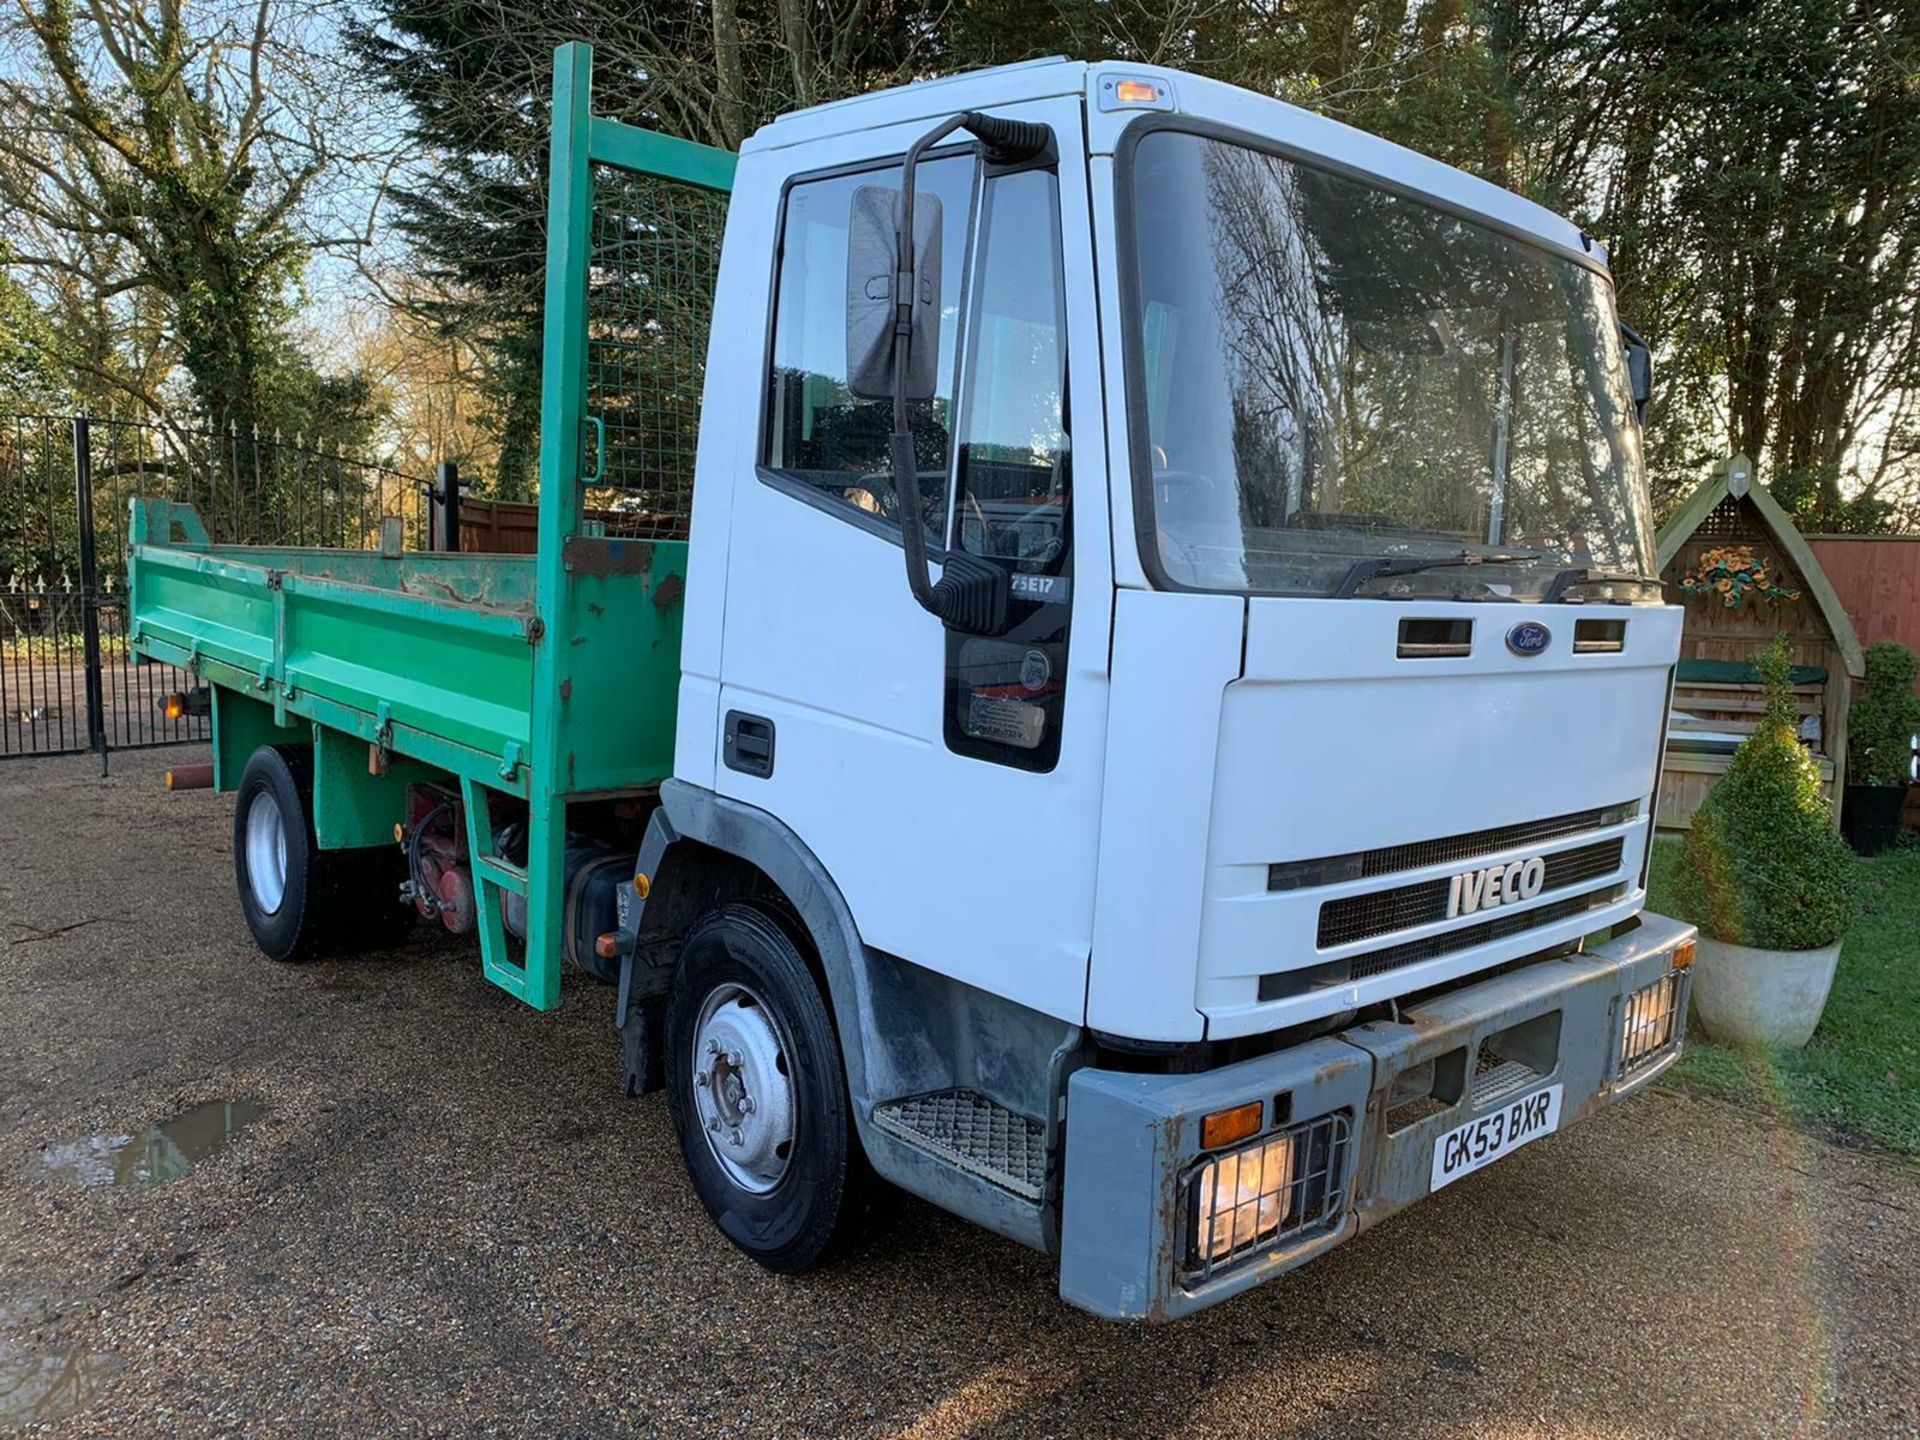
129,499,687,802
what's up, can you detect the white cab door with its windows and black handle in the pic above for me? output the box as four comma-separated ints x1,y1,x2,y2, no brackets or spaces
714,100,1112,1021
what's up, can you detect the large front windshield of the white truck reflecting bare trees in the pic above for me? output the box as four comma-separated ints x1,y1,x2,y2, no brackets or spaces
1129,131,1657,599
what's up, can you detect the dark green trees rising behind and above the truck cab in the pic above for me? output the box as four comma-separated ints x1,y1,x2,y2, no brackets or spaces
355,0,1920,532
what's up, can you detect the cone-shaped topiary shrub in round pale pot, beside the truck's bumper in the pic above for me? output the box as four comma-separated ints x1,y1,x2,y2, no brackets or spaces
1674,636,1853,1050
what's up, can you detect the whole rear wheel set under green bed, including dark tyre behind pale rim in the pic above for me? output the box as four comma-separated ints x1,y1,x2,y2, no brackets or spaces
234,745,413,960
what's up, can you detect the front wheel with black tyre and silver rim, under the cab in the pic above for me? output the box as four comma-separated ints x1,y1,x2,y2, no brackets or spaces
666,904,877,1275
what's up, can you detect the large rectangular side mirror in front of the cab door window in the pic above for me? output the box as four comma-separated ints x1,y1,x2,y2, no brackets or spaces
847,184,941,399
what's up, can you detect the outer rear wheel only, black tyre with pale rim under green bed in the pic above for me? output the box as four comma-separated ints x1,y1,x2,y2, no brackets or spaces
234,745,330,960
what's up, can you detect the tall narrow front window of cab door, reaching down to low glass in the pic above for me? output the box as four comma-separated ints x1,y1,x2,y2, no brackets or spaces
947,171,1073,770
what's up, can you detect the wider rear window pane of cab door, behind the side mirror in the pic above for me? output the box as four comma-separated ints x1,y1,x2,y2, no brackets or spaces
766,154,975,545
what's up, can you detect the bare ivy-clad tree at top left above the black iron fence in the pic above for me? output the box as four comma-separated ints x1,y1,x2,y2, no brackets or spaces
0,0,389,443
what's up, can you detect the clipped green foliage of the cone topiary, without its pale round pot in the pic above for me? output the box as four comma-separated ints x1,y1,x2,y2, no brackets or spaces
1674,636,1853,950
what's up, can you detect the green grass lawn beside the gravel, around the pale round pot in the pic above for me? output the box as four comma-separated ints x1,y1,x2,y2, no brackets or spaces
1649,841,1920,1156
